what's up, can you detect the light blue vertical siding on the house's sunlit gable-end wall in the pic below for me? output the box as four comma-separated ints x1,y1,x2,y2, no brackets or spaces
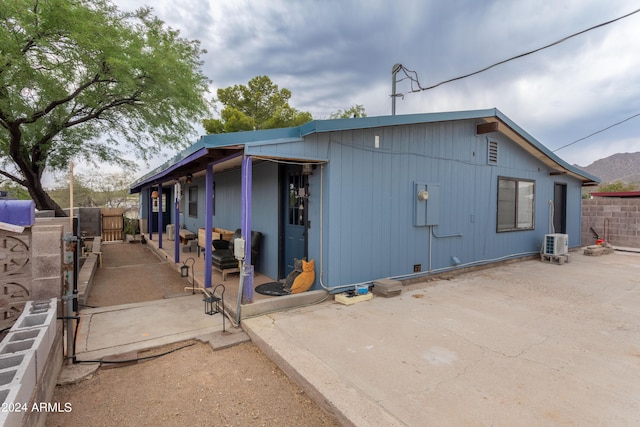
306,121,581,287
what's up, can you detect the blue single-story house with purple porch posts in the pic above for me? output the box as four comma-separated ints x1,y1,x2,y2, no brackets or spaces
131,109,599,300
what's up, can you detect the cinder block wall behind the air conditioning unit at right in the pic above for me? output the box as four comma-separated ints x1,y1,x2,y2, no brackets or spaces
581,197,640,248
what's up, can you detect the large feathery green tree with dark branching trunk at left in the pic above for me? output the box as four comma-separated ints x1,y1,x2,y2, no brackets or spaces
0,0,209,215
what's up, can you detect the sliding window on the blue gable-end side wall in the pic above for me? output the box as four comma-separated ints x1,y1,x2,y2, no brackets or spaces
497,177,535,232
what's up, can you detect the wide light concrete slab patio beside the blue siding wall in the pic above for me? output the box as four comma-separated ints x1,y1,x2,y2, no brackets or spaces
242,252,640,426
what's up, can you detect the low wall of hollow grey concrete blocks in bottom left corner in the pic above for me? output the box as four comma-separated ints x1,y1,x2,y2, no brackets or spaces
0,298,58,426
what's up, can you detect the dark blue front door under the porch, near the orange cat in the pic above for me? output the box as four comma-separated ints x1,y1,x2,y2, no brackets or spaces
281,165,309,277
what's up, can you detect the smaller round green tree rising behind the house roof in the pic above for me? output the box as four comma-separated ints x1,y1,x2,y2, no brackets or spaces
202,76,313,133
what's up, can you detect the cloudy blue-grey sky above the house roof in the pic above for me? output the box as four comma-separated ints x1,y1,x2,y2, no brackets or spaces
113,0,640,172
